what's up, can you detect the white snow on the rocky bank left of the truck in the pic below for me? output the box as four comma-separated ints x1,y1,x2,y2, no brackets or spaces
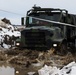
0,22,21,49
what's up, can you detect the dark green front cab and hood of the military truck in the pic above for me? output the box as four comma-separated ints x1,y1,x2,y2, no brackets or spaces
16,6,68,49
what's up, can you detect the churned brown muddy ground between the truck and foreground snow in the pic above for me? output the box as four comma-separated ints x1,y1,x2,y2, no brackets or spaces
0,49,76,75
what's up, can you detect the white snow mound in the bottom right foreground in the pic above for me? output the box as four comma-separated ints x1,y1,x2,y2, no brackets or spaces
38,61,76,75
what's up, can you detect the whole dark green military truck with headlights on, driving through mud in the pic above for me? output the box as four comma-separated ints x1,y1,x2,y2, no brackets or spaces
16,6,76,52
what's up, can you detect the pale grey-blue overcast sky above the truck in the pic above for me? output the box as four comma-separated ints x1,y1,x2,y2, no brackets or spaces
0,0,76,24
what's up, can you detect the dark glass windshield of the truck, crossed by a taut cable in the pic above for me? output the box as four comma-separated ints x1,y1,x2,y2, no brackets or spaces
28,13,60,26
